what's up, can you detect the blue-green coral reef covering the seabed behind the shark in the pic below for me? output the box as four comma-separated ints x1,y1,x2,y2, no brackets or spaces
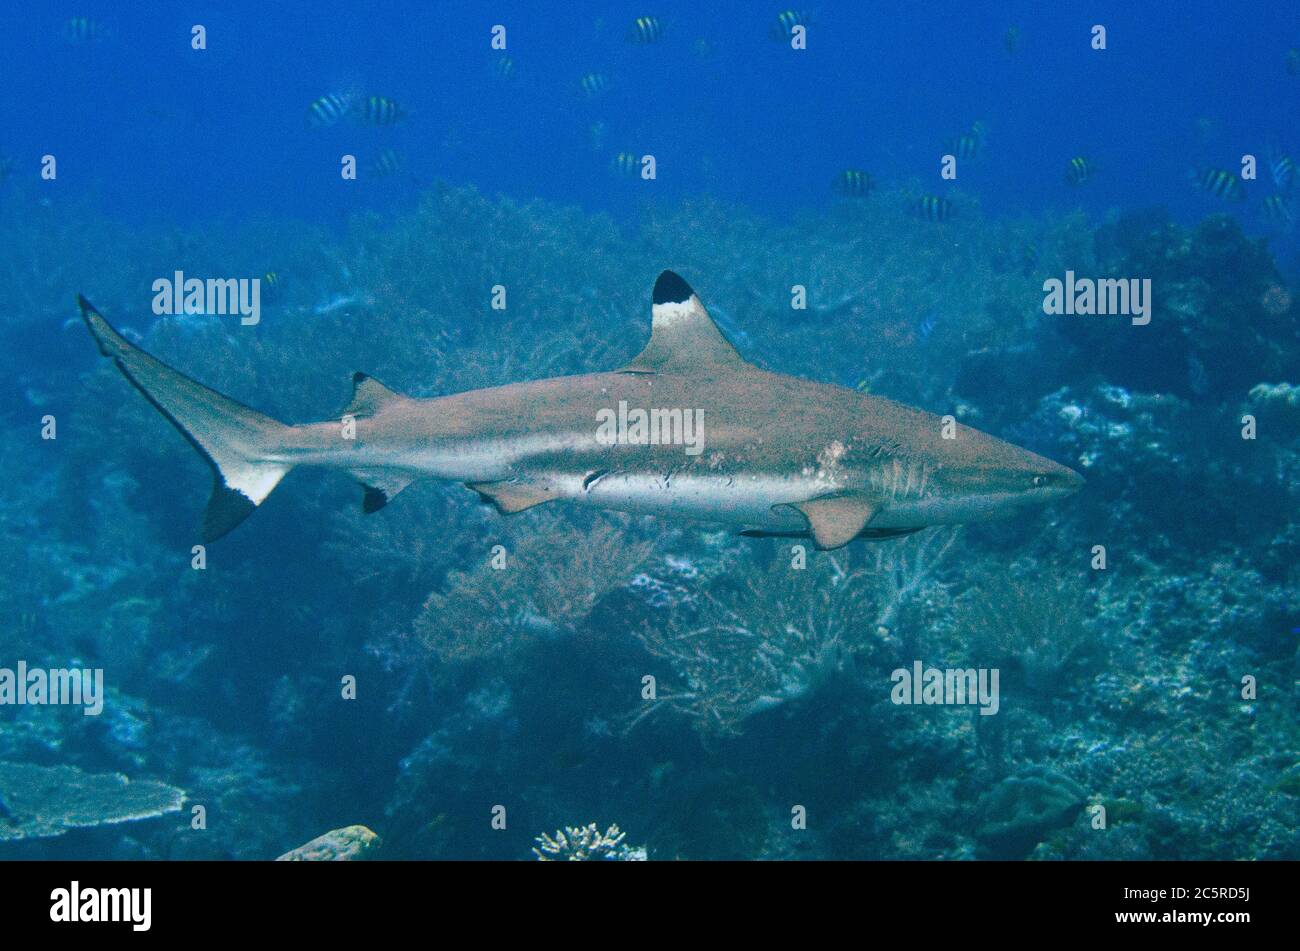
0,177,1300,859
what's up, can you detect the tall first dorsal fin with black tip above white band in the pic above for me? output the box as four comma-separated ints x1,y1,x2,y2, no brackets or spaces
621,270,748,373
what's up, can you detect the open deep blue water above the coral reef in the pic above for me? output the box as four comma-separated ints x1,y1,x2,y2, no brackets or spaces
0,1,1297,231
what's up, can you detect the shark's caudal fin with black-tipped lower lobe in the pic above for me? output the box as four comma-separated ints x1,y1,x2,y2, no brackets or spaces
77,296,293,542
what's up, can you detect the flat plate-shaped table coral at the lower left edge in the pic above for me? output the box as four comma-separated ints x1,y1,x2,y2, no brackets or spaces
0,763,185,842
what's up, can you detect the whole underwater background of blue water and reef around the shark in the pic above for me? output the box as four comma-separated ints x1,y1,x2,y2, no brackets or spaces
0,1,1300,859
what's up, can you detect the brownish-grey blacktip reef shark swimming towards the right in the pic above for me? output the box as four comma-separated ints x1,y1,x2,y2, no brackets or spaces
79,272,1083,548
